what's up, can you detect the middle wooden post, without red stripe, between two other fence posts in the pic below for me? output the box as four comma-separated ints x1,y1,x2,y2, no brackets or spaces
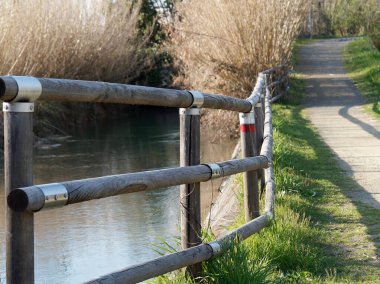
180,105,202,277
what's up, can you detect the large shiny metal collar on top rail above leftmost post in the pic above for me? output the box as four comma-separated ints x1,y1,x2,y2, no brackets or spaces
10,76,42,103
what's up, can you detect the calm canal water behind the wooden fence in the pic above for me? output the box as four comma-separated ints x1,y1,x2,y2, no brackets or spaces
0,108,233,283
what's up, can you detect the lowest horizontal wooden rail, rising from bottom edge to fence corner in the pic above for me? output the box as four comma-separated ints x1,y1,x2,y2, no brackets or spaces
86,214,272,284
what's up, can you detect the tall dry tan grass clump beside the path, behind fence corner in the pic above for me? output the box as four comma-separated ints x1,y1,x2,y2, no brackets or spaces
171,0,308,98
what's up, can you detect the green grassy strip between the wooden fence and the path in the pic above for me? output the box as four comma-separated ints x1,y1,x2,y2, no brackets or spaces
156,74,380,283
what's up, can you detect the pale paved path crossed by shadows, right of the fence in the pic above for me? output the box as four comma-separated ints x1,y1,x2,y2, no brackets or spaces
299,39,380,208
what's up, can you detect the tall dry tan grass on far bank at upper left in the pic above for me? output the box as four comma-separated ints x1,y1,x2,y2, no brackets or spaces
0,0,148,82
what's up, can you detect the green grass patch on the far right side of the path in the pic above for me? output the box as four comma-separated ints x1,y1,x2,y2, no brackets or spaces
344,37,380,118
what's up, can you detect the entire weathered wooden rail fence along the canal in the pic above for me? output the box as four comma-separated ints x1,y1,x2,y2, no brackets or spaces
0,66,288,284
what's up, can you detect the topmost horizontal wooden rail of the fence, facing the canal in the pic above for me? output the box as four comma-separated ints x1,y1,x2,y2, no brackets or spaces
0,76,252,112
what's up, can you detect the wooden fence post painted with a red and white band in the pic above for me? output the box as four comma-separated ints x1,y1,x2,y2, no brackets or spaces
239,110,260,222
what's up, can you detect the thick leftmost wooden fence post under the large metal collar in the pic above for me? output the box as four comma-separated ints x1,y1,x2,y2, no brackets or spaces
3,103,34,284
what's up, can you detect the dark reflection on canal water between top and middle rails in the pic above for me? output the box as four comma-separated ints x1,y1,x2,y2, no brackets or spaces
35,108,179,182
